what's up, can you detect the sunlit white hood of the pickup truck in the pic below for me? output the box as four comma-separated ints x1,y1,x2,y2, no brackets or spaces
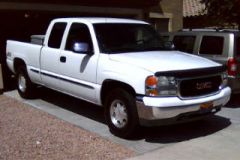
109,51,220,73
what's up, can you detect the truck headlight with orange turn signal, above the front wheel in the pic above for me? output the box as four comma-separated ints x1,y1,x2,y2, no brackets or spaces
145,76,177,96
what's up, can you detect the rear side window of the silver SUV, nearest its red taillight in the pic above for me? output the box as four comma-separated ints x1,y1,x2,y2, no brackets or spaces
200,36,224,55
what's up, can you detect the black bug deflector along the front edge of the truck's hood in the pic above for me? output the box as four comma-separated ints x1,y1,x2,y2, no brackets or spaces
155,65,227,78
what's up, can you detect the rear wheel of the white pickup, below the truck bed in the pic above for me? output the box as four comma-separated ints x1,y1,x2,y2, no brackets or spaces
16,66,36,99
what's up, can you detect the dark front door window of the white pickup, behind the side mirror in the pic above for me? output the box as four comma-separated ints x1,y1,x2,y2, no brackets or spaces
65,23,93,51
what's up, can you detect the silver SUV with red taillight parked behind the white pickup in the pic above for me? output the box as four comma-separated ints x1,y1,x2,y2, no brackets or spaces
160,29,240,93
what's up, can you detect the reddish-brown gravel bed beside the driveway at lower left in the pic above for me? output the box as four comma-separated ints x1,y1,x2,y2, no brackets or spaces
0,95,135,160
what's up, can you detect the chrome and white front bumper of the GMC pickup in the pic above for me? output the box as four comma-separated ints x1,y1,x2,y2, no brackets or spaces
137,87,231,126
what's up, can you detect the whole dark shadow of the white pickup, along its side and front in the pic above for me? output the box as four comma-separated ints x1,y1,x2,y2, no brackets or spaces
39,88,231,144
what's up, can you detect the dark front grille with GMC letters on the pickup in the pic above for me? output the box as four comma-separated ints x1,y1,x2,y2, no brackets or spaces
179,75,222,98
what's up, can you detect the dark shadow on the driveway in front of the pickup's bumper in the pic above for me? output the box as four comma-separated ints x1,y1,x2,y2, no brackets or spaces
139,115,231,144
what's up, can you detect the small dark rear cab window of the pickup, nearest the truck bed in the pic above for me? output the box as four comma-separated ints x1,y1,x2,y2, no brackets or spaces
48,23,67,48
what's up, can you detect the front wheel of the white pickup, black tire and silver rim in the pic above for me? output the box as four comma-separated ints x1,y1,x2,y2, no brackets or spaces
105,88,139,138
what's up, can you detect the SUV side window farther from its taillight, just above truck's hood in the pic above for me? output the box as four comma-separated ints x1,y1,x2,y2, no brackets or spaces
173,36,196,53
